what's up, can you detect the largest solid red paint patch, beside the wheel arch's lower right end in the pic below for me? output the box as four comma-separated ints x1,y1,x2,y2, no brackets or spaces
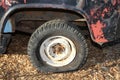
91,20,108,42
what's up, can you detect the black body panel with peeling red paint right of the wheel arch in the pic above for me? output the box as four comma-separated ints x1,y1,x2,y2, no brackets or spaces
85,0,120,42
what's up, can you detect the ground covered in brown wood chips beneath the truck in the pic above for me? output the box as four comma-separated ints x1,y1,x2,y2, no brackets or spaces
0,33,120,80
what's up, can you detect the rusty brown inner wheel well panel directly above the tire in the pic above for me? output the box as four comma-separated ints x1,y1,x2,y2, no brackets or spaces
13,11,87,33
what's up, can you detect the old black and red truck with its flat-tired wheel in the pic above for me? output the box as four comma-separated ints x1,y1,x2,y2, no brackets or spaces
0,0,120,73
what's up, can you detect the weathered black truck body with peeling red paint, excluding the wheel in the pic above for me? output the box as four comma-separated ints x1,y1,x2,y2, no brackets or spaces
0,0,120,72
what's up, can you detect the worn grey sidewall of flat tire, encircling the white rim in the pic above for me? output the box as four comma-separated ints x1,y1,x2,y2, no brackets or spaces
28,28,85,72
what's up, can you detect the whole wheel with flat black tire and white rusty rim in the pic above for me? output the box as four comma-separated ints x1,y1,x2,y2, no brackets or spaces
28,20,88,73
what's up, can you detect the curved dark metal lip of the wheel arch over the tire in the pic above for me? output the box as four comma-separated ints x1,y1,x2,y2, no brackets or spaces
0,4,94,41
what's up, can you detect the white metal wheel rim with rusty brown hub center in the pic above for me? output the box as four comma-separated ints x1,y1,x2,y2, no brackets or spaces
40,36,76,67
